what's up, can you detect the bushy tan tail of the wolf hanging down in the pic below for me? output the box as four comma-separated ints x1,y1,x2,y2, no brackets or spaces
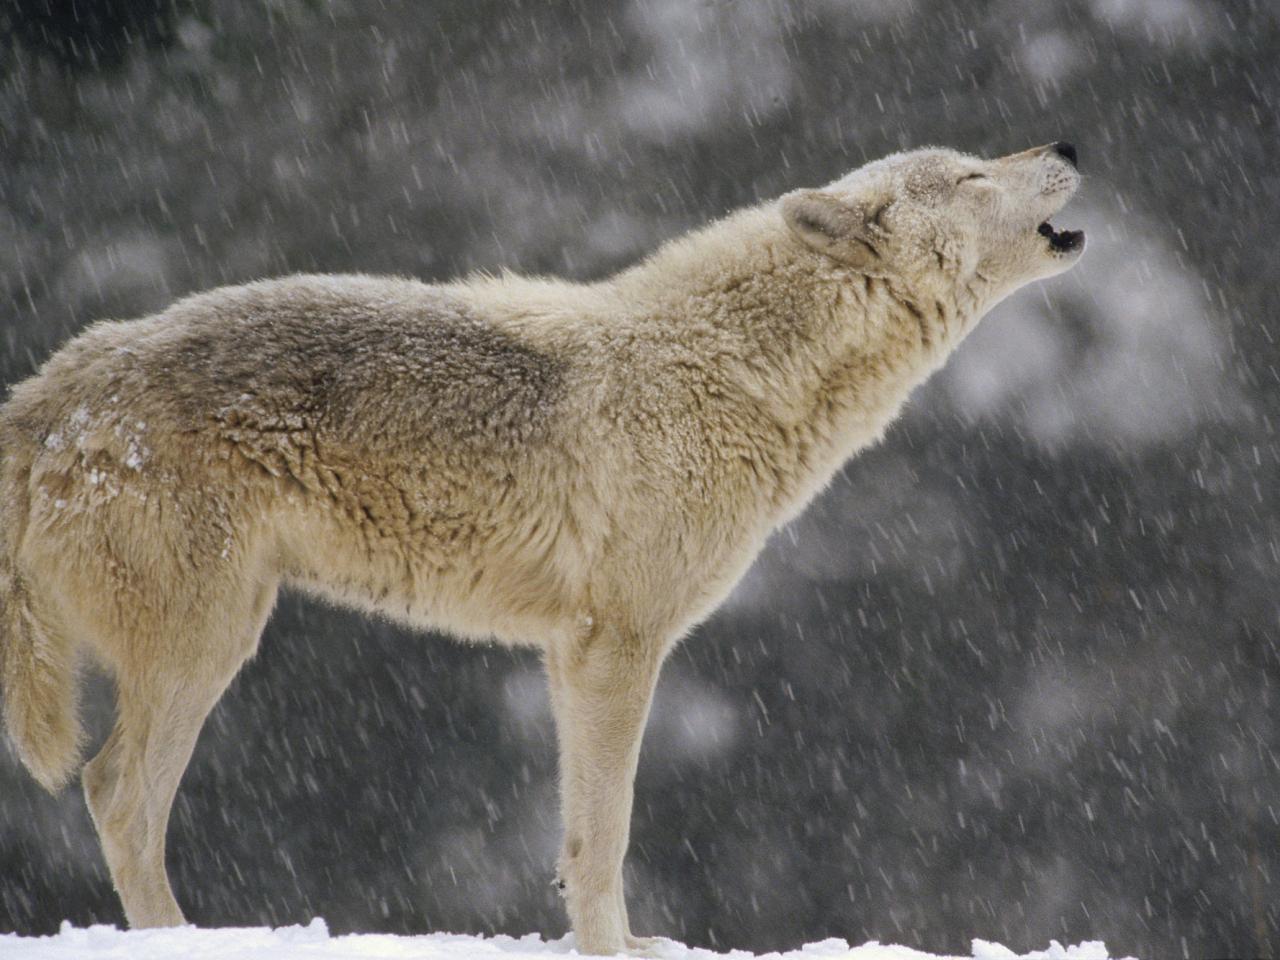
0,454,82,792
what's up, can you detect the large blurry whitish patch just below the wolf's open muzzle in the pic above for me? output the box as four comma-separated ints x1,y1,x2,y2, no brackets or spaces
920,198,1244,448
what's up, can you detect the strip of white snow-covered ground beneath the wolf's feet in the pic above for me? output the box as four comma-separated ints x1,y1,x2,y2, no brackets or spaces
0,919,1131,960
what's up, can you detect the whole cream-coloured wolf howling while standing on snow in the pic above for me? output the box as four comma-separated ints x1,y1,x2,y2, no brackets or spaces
0,142,1084,954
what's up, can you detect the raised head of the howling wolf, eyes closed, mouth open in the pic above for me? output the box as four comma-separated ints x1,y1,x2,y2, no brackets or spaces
781,142,1084,312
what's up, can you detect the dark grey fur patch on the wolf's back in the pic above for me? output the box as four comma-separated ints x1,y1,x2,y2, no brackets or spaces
149,275,564,449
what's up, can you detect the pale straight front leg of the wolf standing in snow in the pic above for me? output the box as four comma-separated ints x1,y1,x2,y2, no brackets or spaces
547,625,663,954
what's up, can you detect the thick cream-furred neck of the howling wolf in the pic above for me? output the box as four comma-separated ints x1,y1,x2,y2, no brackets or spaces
616,206,966,521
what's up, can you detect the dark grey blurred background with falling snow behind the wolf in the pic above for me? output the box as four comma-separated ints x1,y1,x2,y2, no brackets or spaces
0,0,1280,957
